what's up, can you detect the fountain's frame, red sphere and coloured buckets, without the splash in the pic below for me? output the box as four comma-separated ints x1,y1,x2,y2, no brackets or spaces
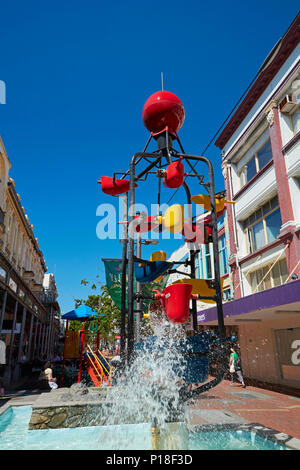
99,90,233,400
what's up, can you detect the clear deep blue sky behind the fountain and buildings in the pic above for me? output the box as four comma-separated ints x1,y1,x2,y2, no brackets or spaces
0,0,298,312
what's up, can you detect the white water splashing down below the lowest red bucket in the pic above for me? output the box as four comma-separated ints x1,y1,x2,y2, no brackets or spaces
105,321,189,427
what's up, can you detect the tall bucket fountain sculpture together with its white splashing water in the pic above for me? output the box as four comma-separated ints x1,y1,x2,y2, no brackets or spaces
97,90,232,448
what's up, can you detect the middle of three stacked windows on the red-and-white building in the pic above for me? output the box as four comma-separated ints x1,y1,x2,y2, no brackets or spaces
244,196,282,253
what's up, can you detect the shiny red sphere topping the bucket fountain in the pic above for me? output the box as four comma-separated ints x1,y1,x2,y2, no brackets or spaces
143,90,185,134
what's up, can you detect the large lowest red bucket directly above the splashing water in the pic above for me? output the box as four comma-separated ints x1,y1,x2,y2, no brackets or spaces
156,283,193,323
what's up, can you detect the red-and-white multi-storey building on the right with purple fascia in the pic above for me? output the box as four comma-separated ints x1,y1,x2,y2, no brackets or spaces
198,15,300,388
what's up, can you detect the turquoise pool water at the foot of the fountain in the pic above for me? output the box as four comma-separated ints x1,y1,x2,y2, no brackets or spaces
0,406,287,450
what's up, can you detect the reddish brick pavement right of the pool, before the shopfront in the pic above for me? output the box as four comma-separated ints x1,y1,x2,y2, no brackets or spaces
189,380,300,439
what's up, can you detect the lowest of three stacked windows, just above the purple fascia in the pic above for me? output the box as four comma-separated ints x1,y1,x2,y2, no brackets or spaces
250,258,288,293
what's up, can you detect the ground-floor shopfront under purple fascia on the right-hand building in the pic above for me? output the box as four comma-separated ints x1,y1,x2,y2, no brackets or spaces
198,280,300,389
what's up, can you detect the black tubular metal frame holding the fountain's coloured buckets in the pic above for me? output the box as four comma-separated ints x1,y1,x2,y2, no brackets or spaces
114,130,227,401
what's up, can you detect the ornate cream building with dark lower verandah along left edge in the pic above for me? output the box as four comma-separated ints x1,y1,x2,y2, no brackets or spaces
0,138,60,384
